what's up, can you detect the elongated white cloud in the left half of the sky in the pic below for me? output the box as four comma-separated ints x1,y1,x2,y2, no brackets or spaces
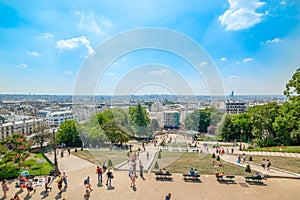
56,36,95,55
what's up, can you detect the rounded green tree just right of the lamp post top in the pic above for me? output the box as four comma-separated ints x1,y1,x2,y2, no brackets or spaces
56,120,82,147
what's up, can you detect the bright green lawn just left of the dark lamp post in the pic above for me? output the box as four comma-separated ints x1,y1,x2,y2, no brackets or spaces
21,153,53,176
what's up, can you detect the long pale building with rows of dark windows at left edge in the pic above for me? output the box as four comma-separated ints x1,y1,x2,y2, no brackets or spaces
0,119,45,139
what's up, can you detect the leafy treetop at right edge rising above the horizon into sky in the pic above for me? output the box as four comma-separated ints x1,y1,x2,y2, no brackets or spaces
283,68,300,101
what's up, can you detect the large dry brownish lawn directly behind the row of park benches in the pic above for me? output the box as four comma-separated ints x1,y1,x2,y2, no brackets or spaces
158,152,254,175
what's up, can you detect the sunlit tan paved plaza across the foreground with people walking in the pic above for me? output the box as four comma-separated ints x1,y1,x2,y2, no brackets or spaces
2,135,300,200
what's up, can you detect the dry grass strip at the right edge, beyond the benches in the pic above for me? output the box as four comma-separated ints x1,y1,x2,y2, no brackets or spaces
248,156,300,174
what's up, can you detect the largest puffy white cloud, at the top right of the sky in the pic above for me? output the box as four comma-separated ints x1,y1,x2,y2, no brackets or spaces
219,0,266,31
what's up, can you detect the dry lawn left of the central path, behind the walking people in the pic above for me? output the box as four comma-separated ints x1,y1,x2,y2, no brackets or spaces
72,149,127,167
